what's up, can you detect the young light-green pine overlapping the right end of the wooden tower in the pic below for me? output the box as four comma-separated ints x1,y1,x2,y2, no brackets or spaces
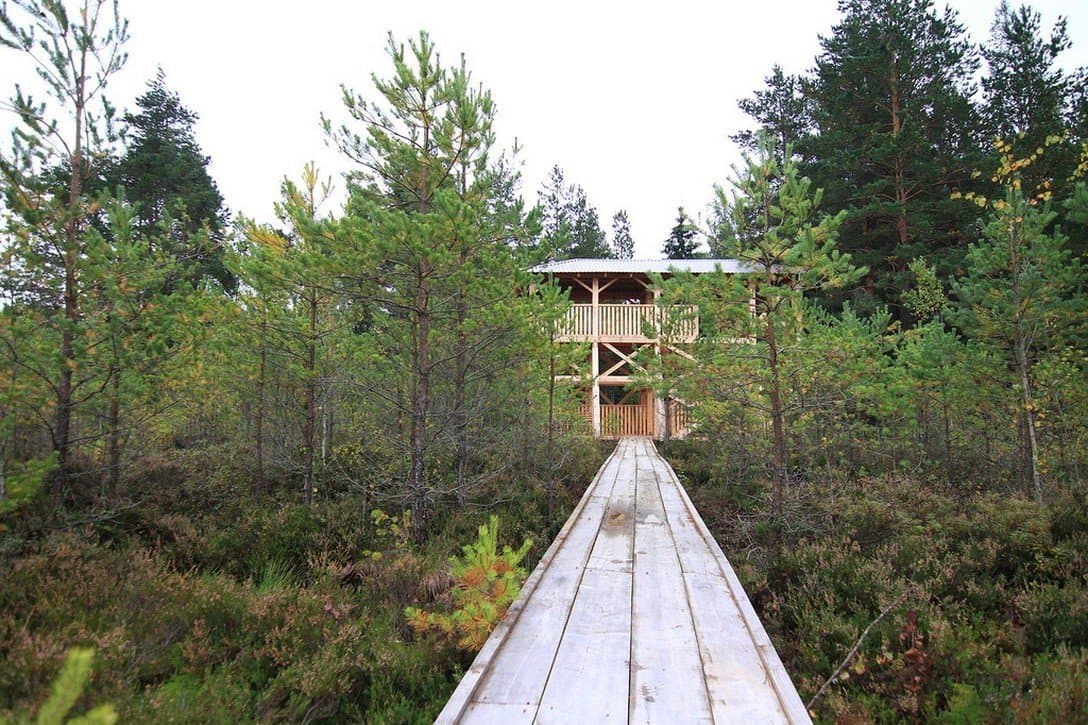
681,136,865,517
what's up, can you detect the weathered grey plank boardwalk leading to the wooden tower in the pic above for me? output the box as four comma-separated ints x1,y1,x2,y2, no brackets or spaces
437,439,809,725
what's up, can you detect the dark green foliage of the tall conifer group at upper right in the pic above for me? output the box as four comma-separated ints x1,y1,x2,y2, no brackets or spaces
732,0,1088,311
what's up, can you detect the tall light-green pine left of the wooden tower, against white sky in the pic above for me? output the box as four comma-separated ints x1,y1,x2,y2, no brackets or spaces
325,33,528,538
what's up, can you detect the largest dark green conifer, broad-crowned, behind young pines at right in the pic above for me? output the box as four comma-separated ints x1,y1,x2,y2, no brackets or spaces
803,0,981,311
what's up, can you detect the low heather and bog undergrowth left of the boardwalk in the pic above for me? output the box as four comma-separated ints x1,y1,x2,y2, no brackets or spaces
0,444,594,723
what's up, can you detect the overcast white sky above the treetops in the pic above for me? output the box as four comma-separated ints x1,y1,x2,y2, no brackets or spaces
6,0,1088,257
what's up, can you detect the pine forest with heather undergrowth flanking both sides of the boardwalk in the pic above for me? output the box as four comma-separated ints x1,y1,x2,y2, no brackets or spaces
0,0,1088,722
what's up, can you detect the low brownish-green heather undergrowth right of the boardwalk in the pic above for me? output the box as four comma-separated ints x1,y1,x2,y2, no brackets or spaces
673,452,1088,723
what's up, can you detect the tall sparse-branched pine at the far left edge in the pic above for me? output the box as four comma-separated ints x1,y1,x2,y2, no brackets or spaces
0,0,127,482
